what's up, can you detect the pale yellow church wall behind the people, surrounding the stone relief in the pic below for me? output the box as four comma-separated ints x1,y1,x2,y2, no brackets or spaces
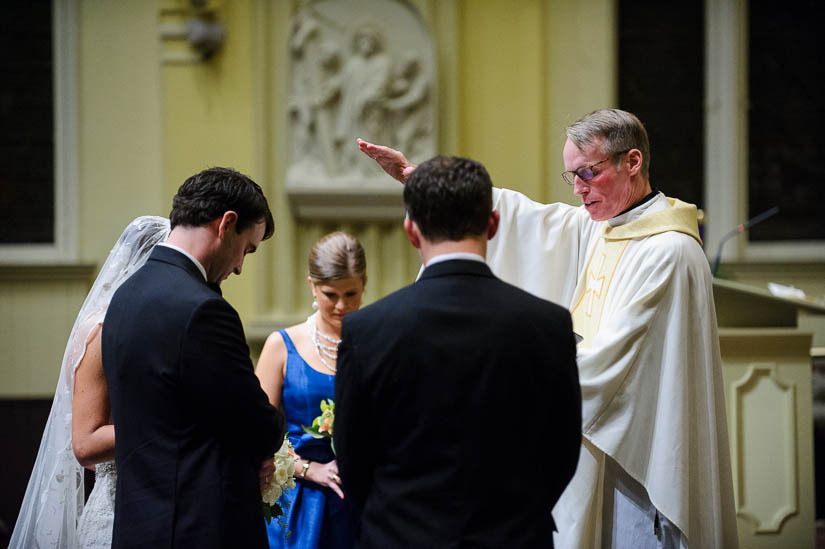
6,0,816,396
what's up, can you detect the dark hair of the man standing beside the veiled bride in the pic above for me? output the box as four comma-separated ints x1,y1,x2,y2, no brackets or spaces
169,168,275,240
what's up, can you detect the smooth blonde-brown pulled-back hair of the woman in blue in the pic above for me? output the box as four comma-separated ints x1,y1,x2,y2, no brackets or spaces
309,231,367,284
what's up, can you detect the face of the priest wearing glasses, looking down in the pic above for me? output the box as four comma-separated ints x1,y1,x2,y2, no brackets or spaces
562,139,641,221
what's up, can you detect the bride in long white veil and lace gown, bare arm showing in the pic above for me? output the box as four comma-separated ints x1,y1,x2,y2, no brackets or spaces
9,216,169,549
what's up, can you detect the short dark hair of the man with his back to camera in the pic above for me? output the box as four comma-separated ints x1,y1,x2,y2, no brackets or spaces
404,156,493,242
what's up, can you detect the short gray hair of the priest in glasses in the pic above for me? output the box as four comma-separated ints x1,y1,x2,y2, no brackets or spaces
565,109,650,179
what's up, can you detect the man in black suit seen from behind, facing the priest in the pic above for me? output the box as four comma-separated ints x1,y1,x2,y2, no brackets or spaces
334,157,581,548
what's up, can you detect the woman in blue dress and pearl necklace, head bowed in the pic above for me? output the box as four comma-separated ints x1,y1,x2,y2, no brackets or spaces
256,232,367,549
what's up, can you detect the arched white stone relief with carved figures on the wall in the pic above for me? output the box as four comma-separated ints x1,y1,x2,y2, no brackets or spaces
286,0,437,219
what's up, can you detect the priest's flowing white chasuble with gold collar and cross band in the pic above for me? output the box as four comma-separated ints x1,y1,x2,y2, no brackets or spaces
487,189,738,549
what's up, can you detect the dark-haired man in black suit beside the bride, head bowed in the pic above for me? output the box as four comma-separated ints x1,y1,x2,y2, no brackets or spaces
102,168,285,548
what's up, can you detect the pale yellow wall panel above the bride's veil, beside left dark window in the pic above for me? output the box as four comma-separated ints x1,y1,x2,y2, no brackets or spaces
78,0,170,262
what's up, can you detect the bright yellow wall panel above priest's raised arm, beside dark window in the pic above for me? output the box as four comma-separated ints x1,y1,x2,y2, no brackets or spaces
458,0,550,200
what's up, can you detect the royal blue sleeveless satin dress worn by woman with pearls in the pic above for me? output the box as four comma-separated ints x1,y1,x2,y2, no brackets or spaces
267,330,355,549
